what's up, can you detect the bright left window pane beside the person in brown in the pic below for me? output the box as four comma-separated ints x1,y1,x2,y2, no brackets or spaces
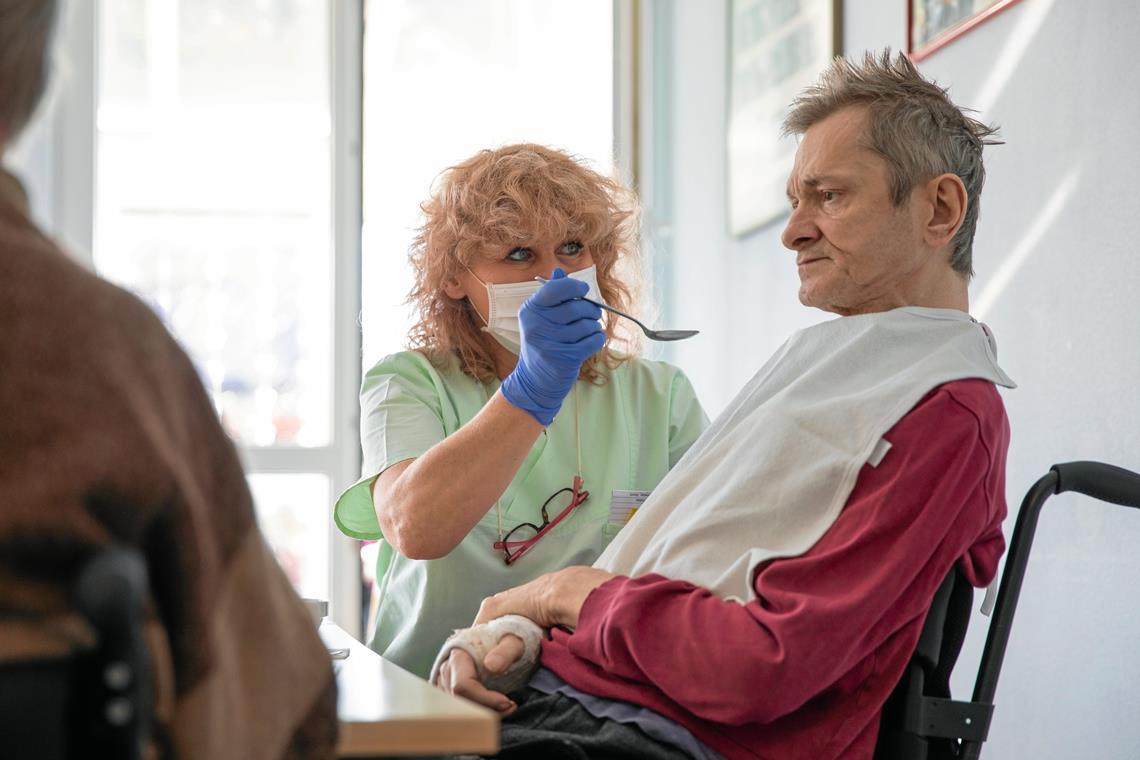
92,0,359,623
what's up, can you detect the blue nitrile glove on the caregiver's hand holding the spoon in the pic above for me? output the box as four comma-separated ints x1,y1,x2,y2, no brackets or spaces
499,269,605,426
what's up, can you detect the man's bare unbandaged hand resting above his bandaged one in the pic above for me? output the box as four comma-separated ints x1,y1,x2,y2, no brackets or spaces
469,566,614,628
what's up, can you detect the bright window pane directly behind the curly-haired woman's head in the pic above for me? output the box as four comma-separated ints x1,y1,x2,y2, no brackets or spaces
361,0,614,367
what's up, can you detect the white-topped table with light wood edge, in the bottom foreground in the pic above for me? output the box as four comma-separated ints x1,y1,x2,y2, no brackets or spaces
320,620,499,758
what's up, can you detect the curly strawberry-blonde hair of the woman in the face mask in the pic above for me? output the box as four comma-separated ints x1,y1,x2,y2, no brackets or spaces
408,144,641,383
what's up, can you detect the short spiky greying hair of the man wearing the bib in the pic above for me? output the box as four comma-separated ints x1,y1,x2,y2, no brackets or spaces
783,48,1001,277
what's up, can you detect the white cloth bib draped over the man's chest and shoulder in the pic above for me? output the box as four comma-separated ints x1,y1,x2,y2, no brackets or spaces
594,307,1015,602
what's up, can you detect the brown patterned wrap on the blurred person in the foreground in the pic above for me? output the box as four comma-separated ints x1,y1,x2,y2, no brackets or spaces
0,171,336,760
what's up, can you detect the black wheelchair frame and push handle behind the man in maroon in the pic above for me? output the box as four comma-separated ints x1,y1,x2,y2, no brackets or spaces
874,461,1140,760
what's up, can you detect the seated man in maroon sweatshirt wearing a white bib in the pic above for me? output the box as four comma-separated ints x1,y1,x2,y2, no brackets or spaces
437,51,1012,760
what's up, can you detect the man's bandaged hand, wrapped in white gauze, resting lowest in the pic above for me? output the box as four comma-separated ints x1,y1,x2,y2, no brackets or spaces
430,615,543,716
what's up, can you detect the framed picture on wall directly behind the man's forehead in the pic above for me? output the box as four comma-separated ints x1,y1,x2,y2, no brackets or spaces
727,0,842,235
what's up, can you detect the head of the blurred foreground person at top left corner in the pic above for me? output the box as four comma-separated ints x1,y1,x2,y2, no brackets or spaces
0,0,56,142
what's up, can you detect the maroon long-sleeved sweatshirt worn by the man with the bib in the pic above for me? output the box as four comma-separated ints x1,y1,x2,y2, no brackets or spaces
542,379,1009,760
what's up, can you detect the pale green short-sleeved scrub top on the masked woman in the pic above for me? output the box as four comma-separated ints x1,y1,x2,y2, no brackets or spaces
334,351,708,678
